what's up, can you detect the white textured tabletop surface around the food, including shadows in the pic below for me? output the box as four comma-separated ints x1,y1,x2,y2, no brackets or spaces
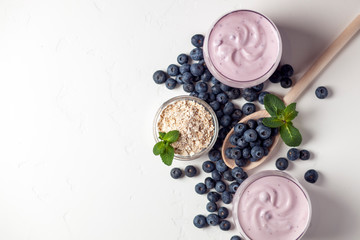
0,0,360,240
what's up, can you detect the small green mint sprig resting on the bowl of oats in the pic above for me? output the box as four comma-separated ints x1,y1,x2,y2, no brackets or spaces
153,130,180,166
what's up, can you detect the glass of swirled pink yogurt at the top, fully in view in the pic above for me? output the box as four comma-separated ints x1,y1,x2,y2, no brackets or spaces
204,10,282,87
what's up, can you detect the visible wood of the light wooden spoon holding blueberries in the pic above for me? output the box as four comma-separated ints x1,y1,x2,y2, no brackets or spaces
221,15,360,170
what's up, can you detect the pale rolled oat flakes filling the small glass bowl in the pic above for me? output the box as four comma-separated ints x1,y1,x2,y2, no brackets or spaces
158,100,215,156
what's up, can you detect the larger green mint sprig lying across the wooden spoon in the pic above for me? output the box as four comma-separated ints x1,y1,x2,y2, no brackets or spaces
263,94,302,147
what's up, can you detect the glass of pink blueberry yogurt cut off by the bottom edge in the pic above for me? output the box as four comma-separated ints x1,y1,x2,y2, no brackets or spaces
234,172,311,240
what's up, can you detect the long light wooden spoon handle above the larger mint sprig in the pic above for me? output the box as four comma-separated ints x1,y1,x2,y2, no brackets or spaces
283,15,360,105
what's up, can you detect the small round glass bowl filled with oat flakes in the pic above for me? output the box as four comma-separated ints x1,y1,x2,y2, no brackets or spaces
153,96,219,160
